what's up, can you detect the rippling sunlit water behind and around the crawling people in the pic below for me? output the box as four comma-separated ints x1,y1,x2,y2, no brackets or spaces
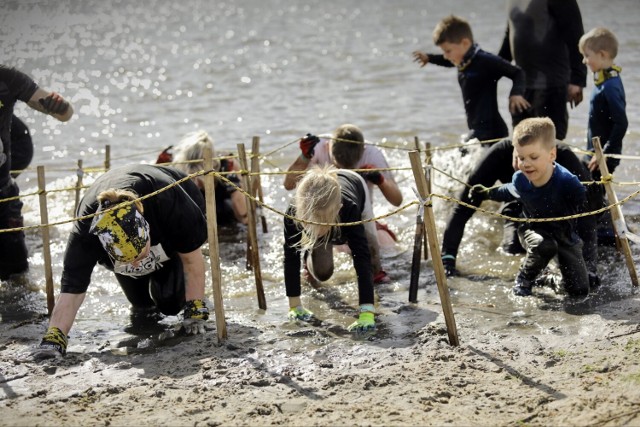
0,0,640,354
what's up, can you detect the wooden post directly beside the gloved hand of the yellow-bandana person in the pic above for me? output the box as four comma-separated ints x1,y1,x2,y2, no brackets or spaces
204,147,227,342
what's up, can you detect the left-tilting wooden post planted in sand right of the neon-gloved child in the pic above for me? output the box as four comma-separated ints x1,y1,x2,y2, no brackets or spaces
409,151,460,346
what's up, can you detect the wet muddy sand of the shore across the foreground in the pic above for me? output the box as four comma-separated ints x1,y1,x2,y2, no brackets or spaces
0,242,640,426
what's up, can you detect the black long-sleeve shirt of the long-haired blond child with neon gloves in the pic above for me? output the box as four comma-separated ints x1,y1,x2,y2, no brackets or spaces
284,171,374,304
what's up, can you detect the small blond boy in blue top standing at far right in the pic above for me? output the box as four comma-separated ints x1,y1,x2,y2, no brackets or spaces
578,28,629,174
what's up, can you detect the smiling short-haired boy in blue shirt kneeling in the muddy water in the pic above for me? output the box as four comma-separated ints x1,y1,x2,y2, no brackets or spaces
471,118,589,296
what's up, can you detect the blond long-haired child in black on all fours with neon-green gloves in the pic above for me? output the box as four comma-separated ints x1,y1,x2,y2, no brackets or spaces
284,166,377,332
